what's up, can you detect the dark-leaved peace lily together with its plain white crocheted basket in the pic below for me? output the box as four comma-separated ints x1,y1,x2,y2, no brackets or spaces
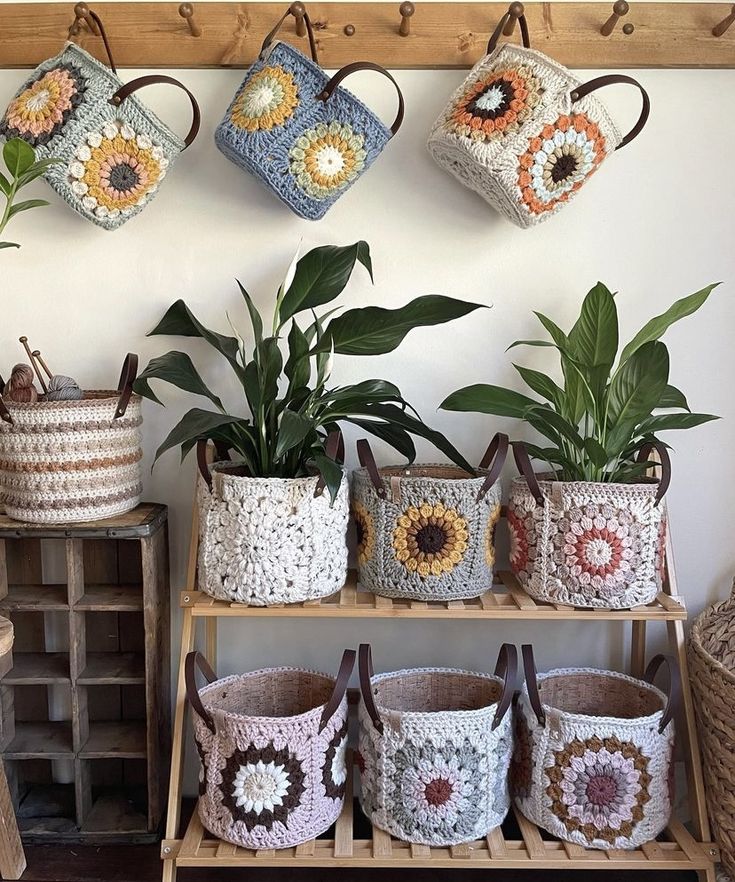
135,242,479,606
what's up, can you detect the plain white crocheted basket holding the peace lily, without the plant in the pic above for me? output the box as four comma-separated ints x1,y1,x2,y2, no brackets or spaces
197,432,350,606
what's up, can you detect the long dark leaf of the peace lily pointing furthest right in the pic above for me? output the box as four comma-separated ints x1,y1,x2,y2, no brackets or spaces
317,294,482,355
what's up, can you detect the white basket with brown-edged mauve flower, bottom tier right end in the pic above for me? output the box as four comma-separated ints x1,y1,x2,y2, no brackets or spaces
510,645,681,850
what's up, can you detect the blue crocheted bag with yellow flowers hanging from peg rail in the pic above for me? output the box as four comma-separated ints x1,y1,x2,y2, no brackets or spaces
215,9,403,220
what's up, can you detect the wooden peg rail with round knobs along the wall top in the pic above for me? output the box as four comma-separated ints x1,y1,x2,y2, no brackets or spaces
0,0,735,69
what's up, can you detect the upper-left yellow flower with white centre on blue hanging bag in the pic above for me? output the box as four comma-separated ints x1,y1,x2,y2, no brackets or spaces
230,67,299,132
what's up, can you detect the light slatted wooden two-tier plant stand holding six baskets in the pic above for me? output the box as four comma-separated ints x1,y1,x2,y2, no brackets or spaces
161,514,718,882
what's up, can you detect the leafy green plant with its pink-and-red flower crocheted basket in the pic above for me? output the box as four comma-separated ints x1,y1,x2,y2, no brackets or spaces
441,282,717,609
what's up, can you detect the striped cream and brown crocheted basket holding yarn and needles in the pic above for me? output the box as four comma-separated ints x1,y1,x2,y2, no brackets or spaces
0,353,143,524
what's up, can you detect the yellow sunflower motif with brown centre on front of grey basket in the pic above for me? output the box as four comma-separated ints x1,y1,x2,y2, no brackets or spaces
393,501,469,579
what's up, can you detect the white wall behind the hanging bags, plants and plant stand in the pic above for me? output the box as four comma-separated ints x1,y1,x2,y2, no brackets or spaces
0,8,735,792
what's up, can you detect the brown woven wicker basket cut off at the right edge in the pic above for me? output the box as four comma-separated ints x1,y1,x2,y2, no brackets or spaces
689,583,735,877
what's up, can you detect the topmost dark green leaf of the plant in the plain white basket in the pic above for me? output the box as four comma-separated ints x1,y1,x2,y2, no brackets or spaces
279,241,372,325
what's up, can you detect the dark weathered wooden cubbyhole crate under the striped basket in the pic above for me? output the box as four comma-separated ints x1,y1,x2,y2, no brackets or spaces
0,504,170,843
